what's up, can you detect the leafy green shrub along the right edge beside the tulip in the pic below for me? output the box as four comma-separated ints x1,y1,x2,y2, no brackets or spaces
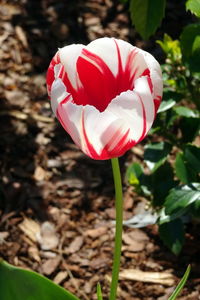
127,0,200,254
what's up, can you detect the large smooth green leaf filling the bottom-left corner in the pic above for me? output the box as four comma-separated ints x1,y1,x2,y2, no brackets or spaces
0,260,78,300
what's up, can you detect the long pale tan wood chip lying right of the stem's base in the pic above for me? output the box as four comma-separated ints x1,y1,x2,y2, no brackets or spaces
119,269,175,286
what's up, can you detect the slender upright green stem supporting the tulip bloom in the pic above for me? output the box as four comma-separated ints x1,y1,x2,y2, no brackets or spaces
109,158,123,300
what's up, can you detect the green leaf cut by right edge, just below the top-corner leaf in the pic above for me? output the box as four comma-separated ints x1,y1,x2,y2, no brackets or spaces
181,23,200,72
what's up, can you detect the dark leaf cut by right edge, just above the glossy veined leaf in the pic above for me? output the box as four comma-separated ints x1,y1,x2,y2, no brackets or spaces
184,144,200,173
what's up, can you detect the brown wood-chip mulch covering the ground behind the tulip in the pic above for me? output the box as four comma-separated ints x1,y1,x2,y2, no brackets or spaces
0,0,200,300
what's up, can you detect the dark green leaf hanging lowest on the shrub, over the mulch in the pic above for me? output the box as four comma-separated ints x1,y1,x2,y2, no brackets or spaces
159,219,185,255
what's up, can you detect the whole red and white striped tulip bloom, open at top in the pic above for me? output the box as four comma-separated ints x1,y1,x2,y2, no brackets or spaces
47,38,162,160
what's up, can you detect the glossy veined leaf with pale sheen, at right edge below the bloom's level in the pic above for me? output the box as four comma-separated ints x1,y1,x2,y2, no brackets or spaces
164,184,200,215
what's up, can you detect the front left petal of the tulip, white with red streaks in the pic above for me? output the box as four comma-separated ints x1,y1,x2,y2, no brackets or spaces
57,101,129,159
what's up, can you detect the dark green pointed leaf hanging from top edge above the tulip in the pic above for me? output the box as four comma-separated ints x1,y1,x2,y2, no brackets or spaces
130,0,166,39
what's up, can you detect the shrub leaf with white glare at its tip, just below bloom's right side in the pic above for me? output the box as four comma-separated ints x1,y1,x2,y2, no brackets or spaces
144,142,172,172
